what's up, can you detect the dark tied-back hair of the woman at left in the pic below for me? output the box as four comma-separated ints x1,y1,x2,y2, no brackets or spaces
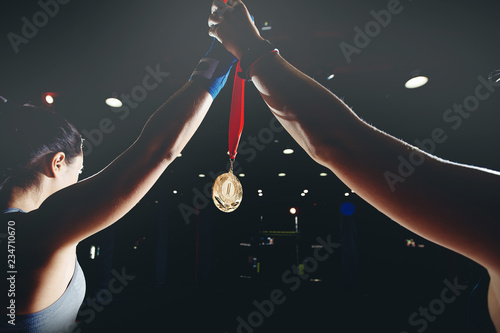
0,98,82,196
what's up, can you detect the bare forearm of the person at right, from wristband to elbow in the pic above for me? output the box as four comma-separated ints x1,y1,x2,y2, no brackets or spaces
249,54,360,164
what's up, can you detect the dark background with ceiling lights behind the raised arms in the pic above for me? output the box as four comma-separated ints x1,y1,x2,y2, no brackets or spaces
0,0,500,333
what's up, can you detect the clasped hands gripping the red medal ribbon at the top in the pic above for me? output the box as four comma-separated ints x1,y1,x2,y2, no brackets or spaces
208,0,263,59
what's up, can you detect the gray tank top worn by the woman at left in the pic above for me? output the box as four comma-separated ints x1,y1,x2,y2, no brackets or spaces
0,208,85,333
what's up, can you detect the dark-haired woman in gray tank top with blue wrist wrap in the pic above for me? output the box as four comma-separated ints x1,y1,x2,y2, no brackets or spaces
0,32,235,333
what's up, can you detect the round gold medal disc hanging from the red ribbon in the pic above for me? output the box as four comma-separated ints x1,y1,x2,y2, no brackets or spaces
212,171,243,213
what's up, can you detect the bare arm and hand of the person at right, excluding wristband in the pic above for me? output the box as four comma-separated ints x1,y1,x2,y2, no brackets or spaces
210,1,500,271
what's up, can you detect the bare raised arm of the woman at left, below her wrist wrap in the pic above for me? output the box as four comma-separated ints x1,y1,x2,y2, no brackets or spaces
33,81,212,248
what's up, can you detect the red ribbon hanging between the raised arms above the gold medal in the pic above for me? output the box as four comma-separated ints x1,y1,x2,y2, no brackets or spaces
229,61,245,160
